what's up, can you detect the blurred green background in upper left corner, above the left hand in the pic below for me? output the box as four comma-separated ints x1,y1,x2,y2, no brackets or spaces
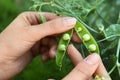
0,0,31,32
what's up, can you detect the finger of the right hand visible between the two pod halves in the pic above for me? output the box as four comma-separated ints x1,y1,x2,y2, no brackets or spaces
67,44,83,65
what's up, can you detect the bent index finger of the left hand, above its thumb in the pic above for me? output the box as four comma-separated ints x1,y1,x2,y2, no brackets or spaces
19,12,58,25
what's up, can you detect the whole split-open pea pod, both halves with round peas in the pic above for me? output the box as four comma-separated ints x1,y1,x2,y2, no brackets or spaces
56,21,99,67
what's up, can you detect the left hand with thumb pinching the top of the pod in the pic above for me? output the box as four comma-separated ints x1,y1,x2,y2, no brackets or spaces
0,12,76,80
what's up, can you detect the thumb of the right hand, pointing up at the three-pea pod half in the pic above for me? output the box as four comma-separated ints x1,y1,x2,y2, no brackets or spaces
63,54,100,80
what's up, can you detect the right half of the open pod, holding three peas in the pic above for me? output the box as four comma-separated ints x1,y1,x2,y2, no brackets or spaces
74,21,99,54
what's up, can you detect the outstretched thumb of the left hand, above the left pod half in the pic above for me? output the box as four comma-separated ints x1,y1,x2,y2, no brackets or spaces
30,17,76,40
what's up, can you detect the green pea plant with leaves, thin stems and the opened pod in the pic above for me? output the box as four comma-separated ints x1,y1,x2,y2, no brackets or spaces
31,0,120,80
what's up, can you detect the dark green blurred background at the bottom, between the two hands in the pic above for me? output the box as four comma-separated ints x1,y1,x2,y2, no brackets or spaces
13,56,73,80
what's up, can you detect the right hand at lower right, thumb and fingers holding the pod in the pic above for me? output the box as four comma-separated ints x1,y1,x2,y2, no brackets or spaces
62,44,111,80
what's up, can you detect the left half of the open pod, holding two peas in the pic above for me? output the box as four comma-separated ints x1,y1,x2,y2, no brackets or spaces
56,29,73,68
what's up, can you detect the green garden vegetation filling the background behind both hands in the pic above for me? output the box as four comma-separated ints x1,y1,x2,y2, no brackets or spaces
0,0,120,80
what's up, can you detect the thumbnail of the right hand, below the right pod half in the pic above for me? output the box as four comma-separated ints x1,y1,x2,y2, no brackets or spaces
85,53,100,65
